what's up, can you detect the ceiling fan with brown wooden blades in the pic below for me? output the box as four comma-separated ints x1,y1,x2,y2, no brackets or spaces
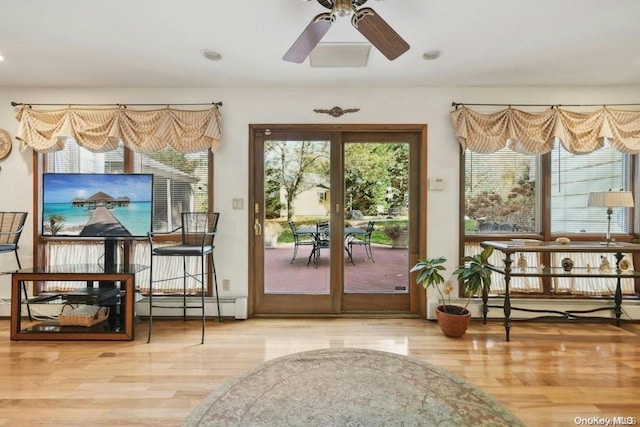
282,0,409,63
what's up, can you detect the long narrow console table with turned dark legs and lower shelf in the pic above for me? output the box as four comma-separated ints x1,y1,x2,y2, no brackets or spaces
480,241,640,341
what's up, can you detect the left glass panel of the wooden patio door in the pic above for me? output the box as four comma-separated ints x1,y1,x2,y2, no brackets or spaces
263,140,331,295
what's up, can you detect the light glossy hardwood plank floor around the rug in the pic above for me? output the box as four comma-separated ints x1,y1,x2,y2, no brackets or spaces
0,318,640,426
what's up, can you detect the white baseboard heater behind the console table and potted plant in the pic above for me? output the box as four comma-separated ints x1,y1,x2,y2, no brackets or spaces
427,298,640,320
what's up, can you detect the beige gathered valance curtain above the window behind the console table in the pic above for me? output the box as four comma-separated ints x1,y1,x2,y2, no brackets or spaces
451,105,640,154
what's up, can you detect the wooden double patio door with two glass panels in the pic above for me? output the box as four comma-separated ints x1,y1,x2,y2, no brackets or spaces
249,125,426,315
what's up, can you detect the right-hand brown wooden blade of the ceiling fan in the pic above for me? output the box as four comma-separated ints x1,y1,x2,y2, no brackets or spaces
351,7,409,61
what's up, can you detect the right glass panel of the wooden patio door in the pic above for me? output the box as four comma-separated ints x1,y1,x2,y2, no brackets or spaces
344,142,410,294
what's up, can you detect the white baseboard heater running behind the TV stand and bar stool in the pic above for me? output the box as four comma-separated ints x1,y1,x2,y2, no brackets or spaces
0,297,248,320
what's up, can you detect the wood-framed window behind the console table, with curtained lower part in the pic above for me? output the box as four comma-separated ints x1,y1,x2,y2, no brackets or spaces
461,140,637,295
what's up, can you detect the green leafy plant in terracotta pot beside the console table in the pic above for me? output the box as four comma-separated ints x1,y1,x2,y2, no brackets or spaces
410,248,493,337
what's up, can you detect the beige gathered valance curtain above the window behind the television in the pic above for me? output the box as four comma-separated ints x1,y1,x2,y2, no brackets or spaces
16,105,222,153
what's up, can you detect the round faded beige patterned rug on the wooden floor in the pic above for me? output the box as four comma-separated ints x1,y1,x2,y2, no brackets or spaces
184,348,523,427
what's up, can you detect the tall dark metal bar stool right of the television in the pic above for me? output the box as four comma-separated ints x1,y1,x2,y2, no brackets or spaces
147,212,222,344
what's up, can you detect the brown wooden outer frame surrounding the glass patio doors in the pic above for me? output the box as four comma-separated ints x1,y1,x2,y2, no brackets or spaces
247,124,427,319
